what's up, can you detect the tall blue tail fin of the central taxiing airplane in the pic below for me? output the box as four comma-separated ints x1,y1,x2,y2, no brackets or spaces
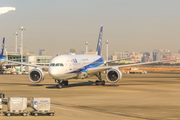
96,25,103,55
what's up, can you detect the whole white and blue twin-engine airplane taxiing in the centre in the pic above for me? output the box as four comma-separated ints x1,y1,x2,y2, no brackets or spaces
0,26,177,88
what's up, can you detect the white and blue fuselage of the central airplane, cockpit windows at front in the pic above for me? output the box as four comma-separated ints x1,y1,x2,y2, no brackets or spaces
48,55,104,79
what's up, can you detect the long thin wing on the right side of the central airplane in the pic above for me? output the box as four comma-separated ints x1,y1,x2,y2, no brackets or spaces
86,59,178,74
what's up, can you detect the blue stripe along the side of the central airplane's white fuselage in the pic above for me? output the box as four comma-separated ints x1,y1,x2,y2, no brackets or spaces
67,57,104,74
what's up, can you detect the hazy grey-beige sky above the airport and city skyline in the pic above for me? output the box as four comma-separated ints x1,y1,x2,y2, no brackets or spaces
0,0,180,57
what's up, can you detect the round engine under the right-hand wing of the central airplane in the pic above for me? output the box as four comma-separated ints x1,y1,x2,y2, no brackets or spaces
106,68,122,83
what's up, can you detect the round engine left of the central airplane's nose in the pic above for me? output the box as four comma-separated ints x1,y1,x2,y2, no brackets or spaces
29,68,45,83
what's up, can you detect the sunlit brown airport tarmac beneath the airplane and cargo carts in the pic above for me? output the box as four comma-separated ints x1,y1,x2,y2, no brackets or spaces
0,73,180,120
